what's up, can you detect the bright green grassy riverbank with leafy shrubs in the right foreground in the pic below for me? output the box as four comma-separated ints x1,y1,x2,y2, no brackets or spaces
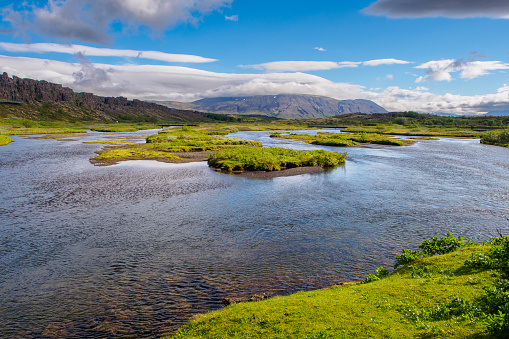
172,235,509,339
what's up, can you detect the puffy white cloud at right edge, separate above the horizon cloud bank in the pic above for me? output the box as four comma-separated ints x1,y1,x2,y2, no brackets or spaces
415,59,509,83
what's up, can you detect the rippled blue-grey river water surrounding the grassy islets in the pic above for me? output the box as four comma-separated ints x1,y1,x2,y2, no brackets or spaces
0,131,509,338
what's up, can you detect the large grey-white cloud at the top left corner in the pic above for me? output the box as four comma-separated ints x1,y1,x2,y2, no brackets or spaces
2,0,233,44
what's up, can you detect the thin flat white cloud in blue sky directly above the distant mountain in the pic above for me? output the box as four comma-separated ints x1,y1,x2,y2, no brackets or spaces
240,61,361,72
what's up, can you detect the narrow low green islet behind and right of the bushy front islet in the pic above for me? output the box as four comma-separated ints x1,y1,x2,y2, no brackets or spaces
270,132,415,147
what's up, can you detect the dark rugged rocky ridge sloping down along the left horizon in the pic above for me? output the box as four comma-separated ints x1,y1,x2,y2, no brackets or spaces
0,73,206,121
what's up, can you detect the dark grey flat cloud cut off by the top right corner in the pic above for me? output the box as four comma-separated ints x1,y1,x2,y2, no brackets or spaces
362,0,509,19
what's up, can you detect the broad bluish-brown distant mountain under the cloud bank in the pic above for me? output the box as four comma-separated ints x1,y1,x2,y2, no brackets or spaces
161,94,387,119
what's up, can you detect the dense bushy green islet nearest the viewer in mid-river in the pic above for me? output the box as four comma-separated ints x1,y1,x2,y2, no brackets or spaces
208,147,346,172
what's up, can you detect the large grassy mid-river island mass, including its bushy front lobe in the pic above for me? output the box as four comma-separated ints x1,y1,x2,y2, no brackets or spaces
92,124,346,172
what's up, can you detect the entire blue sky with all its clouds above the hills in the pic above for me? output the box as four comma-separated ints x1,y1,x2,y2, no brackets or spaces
0,0,509,114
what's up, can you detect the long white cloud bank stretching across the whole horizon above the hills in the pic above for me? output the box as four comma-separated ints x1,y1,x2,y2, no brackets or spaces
0,55,509,114
